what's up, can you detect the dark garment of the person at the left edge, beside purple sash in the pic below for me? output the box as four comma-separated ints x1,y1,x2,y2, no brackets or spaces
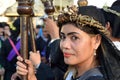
0,39,17,80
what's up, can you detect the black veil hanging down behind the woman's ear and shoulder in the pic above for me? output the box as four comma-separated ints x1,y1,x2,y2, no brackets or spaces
97,34,120,80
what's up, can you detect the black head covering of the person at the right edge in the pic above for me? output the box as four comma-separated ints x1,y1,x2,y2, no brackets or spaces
103,0,120,38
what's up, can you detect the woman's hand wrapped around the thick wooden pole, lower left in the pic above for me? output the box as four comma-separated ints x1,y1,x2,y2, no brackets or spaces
16,56,37,80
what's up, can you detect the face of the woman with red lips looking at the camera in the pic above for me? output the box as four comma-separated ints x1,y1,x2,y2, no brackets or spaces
60,24,100,65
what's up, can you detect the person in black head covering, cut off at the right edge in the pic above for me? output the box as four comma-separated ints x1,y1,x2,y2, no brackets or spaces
103,0,120,50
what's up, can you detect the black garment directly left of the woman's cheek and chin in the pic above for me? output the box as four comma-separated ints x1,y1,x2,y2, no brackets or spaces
47,39,68,80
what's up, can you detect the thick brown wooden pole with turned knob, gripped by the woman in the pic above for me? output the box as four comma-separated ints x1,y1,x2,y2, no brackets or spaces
17,0,35,80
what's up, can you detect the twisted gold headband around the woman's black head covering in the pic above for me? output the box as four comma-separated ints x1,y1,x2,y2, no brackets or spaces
58,6,108,35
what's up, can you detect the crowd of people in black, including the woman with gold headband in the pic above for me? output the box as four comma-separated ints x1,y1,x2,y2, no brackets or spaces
0,0,120,80
